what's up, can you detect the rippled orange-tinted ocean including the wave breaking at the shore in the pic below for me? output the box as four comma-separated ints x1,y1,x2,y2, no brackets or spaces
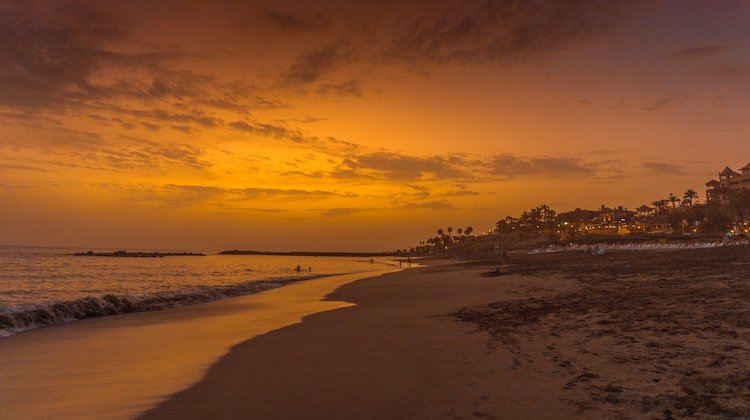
0,246,397,337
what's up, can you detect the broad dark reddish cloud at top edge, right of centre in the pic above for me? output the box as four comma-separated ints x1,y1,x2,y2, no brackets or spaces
383,0,627,64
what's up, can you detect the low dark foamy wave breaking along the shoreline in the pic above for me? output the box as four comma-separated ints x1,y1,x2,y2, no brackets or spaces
0,274,337,337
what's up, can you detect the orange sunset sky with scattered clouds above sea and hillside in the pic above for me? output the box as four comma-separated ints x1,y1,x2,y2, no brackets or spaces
0,0,750,251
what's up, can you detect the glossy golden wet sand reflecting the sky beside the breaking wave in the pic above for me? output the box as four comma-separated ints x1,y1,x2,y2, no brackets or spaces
0,270,400,419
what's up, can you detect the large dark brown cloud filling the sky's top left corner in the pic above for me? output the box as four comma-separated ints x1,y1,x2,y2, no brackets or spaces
0,2,171,109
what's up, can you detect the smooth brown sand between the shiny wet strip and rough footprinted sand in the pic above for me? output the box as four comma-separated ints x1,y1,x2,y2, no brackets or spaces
143,267,575,419
